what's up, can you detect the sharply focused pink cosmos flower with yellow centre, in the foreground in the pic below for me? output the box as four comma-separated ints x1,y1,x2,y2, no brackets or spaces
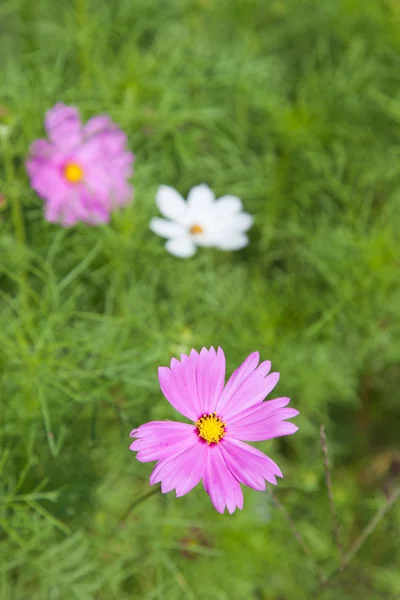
130,347,299,513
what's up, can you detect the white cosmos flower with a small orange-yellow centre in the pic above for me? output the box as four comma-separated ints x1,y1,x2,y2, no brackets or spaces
150,183,253,258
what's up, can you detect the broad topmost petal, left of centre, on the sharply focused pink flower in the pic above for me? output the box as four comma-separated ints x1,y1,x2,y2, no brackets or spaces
158,348,225,421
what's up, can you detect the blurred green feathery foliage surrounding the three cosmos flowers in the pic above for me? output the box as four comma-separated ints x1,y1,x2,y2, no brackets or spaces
0,0,400,600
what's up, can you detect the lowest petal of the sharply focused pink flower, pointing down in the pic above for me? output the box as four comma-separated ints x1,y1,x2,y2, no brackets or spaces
203,445,243,514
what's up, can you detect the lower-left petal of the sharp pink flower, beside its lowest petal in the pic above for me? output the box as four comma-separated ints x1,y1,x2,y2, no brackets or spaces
150,439,208,497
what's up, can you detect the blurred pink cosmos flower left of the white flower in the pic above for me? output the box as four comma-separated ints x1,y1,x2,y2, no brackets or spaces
26,103,134,227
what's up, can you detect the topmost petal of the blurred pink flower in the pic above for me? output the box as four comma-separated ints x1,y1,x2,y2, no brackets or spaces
45,102,82,151
